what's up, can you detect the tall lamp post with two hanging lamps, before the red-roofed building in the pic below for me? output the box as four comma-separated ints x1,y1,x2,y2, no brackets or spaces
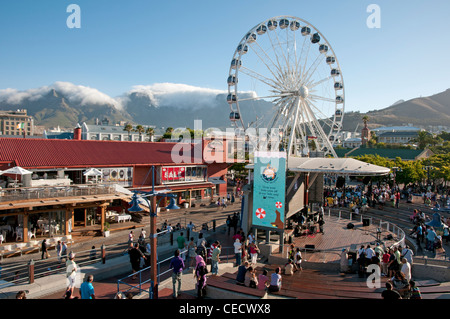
128,166,180,299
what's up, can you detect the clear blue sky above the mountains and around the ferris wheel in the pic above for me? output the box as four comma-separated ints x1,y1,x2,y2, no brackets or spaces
0,0,450,112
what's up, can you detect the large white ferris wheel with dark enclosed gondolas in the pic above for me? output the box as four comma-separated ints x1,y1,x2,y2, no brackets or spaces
227,16,345,157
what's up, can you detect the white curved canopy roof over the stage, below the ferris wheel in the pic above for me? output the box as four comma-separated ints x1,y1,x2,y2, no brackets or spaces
245,156,391,176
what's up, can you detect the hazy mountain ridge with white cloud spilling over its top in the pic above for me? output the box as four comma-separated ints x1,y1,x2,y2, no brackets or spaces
0,82,450,131
